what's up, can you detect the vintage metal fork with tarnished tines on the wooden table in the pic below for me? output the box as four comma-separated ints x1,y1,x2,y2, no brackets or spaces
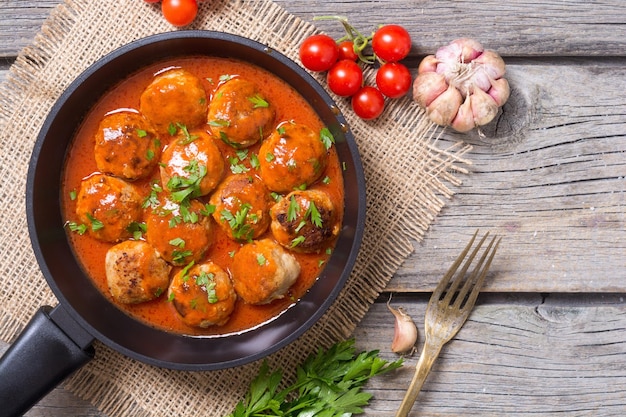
396,231,501,417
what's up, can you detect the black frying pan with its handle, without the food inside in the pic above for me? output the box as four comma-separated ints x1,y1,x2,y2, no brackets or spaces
0,31,365,416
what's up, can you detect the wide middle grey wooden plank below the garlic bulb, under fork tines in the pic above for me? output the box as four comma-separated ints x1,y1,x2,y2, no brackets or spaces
388,63,626,292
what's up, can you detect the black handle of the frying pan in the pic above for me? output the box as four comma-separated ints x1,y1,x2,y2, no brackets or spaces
0,305,94,417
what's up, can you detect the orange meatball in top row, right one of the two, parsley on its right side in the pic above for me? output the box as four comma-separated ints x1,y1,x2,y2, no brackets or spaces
207,78,275,148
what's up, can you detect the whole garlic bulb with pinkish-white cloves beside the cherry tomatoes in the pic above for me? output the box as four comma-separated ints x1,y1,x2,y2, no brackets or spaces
413,38,510,132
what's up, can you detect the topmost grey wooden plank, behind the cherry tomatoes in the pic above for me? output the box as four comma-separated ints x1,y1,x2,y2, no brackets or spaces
0,0,626,57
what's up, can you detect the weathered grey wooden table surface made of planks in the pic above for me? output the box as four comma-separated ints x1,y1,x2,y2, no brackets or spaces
0,0,626,417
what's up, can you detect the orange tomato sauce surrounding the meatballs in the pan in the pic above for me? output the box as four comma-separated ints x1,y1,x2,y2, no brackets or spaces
62,57,343,336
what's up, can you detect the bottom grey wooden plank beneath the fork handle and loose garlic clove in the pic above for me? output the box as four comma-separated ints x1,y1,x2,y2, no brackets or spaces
356,296,626,417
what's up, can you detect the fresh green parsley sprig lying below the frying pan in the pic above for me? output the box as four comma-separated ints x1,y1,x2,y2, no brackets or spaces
227,339,402,417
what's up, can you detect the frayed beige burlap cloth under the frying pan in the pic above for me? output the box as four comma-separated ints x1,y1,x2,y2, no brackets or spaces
0,0,469,417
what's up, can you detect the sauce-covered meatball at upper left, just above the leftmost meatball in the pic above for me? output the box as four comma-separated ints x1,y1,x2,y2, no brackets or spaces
94,111,161,181
